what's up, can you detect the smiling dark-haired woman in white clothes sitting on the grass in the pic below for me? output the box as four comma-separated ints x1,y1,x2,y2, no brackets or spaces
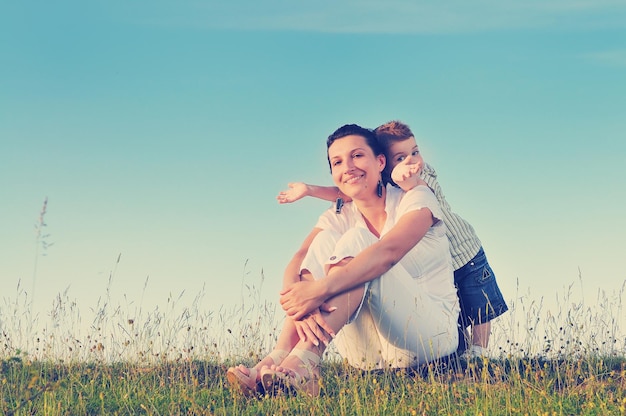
227,124,459,396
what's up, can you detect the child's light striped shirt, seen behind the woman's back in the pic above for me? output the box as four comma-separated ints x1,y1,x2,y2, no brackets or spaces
420,163,482,270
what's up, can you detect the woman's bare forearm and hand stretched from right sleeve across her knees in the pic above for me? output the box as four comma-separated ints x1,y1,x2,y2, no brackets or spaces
280,208,433,319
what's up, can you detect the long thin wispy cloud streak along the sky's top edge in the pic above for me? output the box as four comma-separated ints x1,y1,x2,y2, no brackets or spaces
119,0,626,34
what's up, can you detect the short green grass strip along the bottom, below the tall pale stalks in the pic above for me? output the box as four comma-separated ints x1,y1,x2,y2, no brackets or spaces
0,357,626,415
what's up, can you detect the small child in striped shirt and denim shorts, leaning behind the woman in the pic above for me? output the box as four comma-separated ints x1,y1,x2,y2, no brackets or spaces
277,121,508,357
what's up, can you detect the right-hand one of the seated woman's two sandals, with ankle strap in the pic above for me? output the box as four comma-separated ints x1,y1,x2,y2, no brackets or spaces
261,348,320,397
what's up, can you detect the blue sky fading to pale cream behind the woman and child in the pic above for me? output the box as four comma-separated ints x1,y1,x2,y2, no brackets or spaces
0,0,626,332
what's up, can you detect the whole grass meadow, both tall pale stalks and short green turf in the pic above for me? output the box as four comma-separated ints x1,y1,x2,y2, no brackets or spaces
0,272,626,415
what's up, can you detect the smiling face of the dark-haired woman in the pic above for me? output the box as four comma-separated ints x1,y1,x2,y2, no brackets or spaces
328,135,385,199
